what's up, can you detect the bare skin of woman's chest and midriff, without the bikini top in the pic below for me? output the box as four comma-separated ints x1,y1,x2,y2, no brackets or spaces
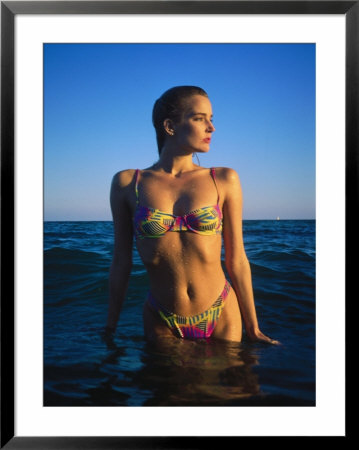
130,168,225,316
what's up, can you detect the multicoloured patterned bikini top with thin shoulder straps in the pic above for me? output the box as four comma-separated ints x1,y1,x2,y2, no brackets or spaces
133,168,223,239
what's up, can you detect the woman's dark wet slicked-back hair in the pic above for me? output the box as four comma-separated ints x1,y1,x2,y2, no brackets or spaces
152,86,208,154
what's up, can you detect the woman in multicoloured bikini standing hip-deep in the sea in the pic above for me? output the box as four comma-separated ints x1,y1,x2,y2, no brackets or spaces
106,86,277,344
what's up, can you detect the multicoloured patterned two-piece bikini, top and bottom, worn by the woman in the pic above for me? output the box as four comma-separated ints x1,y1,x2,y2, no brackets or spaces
133,168,231,338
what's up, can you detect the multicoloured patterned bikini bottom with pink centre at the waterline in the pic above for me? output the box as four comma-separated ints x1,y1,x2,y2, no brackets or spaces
147,280,231,339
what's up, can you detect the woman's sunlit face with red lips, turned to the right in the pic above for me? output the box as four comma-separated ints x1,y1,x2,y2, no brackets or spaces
173,95,215,153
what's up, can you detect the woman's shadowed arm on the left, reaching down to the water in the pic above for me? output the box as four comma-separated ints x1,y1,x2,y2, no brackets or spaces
106,170,133,332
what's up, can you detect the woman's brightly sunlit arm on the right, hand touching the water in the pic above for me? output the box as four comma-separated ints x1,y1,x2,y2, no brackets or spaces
222,169,278,344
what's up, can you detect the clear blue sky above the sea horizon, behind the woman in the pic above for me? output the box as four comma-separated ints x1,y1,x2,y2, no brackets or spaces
44,44,315,220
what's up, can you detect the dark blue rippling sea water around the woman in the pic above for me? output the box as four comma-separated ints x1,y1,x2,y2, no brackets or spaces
44,220,315,406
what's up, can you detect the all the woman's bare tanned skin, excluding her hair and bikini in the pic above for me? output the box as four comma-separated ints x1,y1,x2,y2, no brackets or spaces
107,95,277,343
